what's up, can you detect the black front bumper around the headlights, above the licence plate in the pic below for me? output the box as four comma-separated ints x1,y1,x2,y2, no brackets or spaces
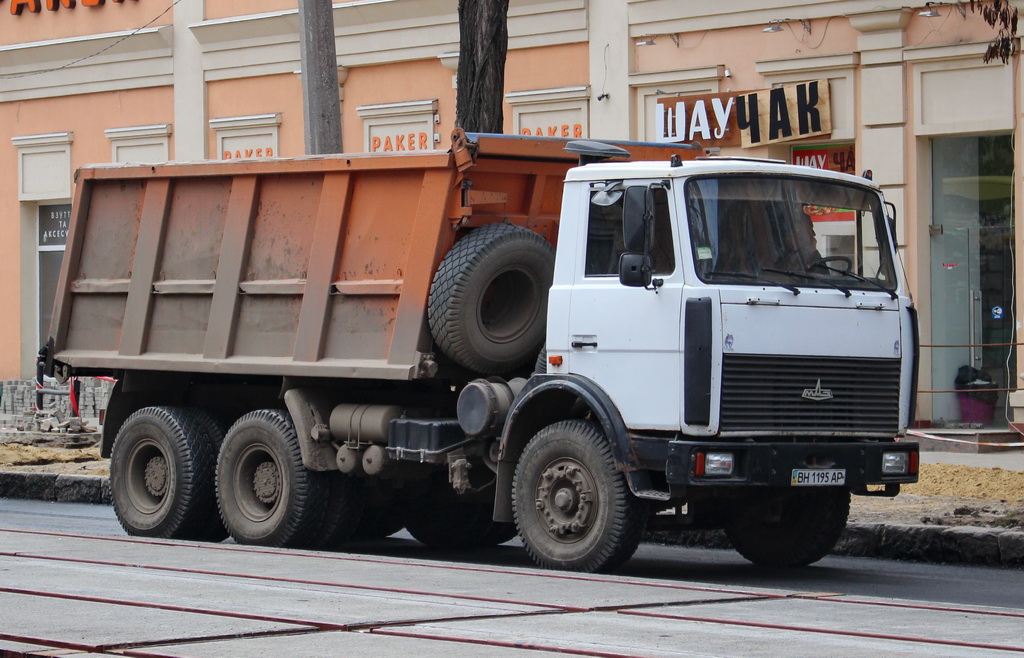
665,441,919,491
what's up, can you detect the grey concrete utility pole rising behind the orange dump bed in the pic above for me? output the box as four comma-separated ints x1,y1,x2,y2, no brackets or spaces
299,0,341,156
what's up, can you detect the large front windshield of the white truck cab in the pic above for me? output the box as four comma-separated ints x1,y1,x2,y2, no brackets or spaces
686,175,896,296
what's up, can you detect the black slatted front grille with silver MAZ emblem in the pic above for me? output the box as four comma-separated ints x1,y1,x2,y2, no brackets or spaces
720,354,900,436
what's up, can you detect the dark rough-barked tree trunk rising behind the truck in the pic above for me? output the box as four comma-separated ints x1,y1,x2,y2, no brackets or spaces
456,0,509,133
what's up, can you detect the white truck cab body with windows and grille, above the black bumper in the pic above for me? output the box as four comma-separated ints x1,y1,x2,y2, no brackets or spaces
547,159,914,437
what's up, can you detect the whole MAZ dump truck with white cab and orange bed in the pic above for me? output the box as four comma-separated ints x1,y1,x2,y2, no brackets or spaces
41,131,918,571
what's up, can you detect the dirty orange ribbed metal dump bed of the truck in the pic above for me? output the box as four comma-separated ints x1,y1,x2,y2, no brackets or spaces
51,133,697,380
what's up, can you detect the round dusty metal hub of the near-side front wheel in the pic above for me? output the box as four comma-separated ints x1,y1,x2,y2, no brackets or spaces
537,459,595,541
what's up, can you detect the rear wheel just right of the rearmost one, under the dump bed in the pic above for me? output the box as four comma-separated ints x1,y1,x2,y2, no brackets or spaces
217,409,329,546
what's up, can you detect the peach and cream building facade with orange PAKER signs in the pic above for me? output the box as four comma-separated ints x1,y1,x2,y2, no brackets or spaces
0,0,1024,427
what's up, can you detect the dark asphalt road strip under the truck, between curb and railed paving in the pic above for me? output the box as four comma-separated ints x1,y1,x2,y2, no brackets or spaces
0,498,1024,613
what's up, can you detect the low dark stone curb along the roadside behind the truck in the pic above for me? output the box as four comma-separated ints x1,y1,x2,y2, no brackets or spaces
0,471,1024,567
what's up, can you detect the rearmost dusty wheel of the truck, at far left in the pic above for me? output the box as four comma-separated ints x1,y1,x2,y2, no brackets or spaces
111,406,216,539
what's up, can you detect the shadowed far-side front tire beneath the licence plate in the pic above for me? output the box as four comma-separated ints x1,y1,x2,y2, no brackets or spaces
725,488,850,567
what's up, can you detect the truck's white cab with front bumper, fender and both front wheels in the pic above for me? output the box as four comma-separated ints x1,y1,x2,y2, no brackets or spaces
495,153,918,569
